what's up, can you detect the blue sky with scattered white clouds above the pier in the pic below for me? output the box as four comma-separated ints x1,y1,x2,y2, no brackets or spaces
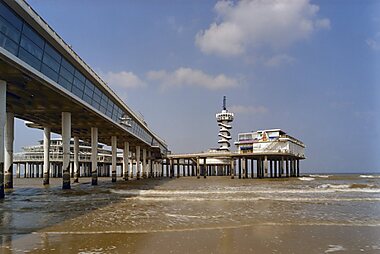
15,0,380,173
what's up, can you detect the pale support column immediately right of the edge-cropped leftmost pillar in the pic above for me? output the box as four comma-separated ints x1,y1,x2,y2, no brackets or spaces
4,112,14,189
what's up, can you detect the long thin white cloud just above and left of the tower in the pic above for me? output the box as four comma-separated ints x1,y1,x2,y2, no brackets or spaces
147,67,238,90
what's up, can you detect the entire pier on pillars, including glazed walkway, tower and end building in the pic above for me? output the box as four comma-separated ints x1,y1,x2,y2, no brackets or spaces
0,0,305,198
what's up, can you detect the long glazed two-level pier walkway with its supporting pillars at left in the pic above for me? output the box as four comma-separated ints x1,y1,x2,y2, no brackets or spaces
0,0,168,198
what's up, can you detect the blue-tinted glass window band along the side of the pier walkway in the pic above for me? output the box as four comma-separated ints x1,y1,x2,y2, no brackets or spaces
0,0,165,150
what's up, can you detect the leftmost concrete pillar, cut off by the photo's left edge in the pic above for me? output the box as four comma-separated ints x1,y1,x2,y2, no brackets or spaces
0,80,7,199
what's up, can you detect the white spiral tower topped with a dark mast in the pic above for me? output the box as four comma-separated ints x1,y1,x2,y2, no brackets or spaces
216,96,234,152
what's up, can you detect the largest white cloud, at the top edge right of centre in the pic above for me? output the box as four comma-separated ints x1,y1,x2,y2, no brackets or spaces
195,0,330,56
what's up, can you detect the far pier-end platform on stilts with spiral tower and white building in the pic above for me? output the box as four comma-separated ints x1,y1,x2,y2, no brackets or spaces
166,96,305,178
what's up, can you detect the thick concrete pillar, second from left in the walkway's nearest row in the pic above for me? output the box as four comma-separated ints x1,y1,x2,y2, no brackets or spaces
62,112,71,189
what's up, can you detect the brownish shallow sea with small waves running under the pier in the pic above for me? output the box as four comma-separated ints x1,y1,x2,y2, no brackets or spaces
0,174,380,254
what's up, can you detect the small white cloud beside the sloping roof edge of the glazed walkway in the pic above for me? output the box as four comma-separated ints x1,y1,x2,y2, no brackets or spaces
103,71,145,89
